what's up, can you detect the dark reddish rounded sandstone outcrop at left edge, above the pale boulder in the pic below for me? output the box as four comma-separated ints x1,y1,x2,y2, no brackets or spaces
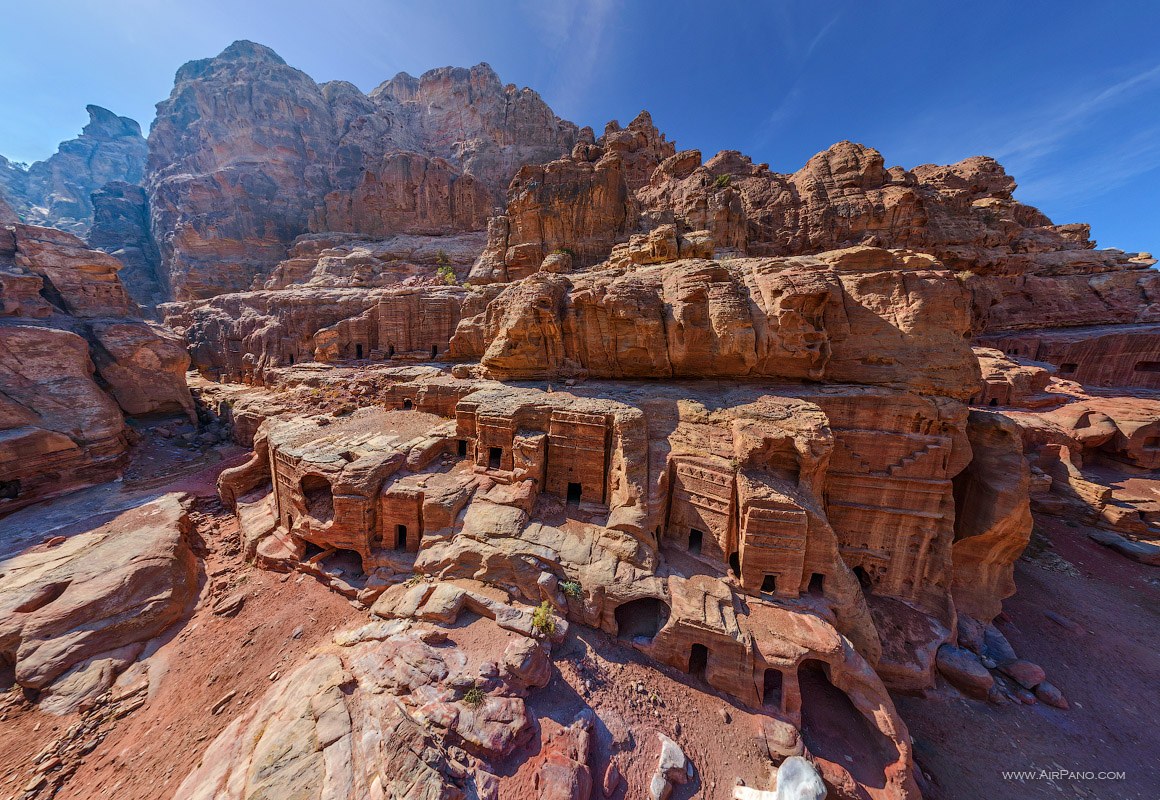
0,224,193,514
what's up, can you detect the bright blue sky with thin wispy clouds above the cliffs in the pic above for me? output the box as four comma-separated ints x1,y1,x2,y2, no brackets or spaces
0,0,1160,253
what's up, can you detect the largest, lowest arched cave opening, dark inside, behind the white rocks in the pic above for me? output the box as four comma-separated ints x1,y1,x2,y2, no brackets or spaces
798,659,898,788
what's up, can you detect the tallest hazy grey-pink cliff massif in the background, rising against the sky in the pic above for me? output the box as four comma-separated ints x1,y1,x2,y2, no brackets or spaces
146,42,579,299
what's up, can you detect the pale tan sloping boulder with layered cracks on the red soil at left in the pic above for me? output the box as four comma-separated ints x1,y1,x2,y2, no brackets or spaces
0,494,197,713
